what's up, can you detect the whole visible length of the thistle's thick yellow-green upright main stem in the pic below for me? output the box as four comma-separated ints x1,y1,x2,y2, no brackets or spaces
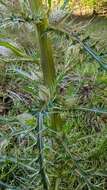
29,0,61,130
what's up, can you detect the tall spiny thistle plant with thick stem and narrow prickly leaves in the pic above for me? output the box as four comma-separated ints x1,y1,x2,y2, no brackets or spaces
0,0,107,190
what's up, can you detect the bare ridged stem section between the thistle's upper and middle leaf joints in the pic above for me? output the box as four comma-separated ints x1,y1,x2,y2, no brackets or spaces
37,22,55,88
